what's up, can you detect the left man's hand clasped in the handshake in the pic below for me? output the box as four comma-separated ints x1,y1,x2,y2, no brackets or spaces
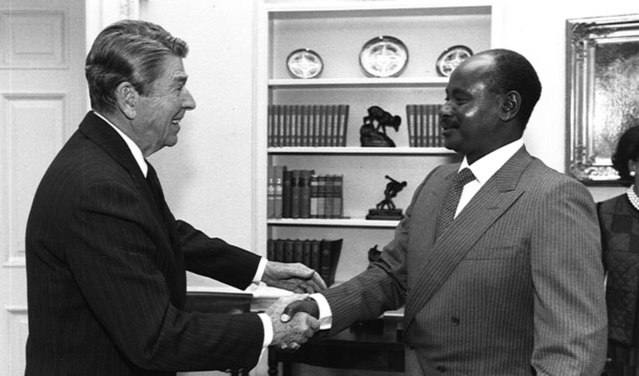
266,294,319,350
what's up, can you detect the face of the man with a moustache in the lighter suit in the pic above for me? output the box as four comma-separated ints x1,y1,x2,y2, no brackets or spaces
440,55,503,163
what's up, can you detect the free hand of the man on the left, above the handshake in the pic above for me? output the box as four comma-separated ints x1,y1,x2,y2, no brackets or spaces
262,261,326,293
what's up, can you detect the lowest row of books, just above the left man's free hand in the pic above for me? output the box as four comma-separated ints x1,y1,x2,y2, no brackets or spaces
266,239,343,286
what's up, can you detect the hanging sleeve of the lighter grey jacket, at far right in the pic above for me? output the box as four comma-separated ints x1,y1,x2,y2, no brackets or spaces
530,180,607,376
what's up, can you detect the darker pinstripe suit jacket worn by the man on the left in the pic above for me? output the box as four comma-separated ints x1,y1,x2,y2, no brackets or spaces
26,113,263,376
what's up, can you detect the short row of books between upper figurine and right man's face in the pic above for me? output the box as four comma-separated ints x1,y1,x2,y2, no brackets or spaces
406,104,444,147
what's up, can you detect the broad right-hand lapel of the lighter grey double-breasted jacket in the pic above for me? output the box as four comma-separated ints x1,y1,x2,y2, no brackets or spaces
404,148,532,327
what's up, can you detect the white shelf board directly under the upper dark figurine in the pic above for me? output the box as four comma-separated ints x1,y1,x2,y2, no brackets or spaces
267,146,455,155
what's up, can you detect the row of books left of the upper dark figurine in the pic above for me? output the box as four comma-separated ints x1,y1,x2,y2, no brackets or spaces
268,104,349,147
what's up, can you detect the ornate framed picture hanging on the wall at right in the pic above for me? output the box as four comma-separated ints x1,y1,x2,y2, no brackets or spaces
566,14,639,184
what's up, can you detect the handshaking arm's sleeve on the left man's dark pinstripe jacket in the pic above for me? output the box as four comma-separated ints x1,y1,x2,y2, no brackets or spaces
65,182,263,371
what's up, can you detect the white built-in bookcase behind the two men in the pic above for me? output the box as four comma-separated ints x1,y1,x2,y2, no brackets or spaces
256,1,495,282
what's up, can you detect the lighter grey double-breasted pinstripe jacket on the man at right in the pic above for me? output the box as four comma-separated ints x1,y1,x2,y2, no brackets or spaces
325,148,607,376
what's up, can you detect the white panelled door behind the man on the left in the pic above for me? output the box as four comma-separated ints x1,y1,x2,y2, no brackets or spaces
0,0,87,376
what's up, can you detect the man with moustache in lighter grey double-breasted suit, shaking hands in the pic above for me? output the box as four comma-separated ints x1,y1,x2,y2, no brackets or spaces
283,50,607,376
